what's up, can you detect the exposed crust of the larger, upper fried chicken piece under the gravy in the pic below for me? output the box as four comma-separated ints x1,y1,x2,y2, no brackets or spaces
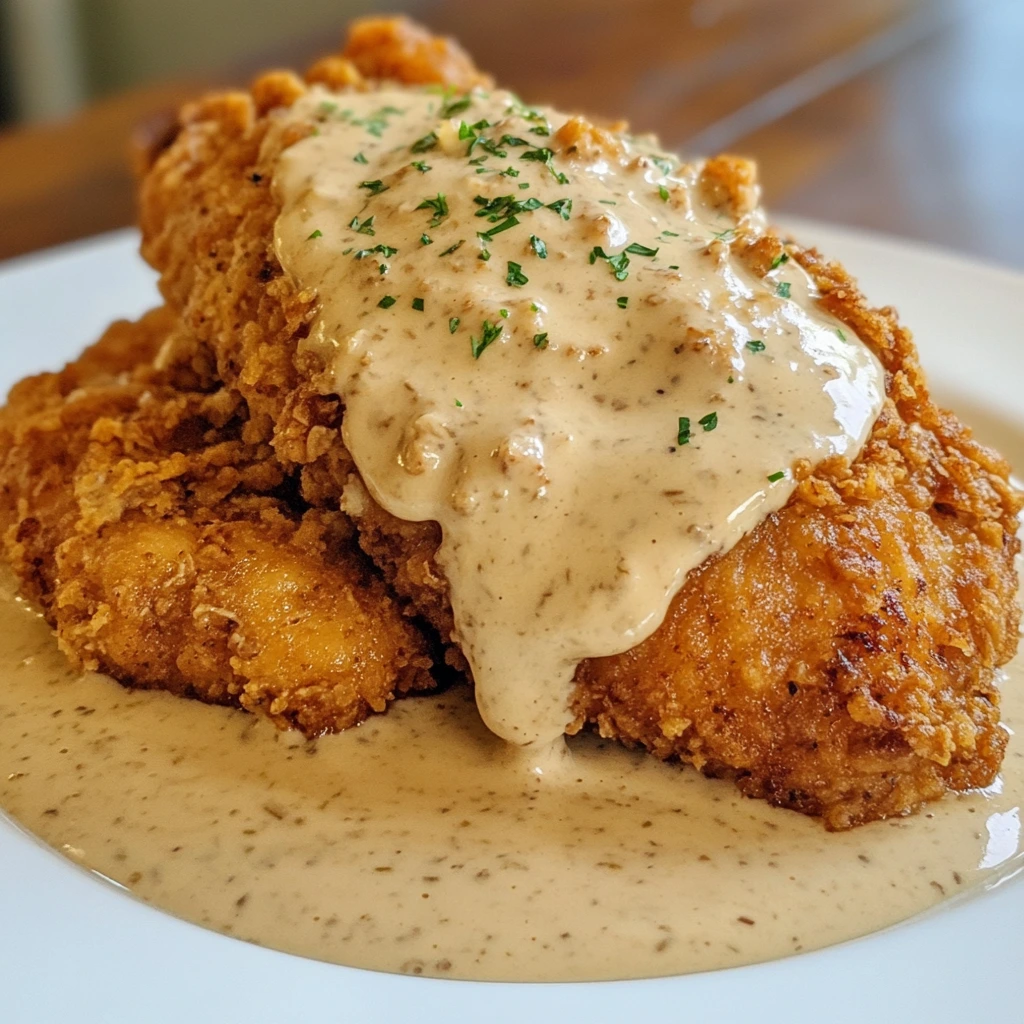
4,22,1020,828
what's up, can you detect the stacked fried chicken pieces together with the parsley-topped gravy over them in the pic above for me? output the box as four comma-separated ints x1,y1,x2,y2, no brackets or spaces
0,19,1021,828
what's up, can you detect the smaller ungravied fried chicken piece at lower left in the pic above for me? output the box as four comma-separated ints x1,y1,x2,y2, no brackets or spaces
0,309,433,734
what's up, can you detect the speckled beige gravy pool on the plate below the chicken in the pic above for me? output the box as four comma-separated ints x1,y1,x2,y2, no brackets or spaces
0,578,1024,980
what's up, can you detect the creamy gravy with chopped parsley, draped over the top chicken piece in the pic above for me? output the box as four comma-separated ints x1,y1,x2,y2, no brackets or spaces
273,87,883,744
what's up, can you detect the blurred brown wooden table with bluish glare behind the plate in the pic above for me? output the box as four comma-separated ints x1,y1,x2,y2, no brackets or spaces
0,0,1024,266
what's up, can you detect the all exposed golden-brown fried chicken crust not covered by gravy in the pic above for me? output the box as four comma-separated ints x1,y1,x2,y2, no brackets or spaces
0,19,1021,828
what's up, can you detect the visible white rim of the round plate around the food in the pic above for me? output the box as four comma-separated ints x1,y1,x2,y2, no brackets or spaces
0,222,1024,1024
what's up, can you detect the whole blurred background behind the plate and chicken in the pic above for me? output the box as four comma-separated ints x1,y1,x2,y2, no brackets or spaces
0,0,1024,266
